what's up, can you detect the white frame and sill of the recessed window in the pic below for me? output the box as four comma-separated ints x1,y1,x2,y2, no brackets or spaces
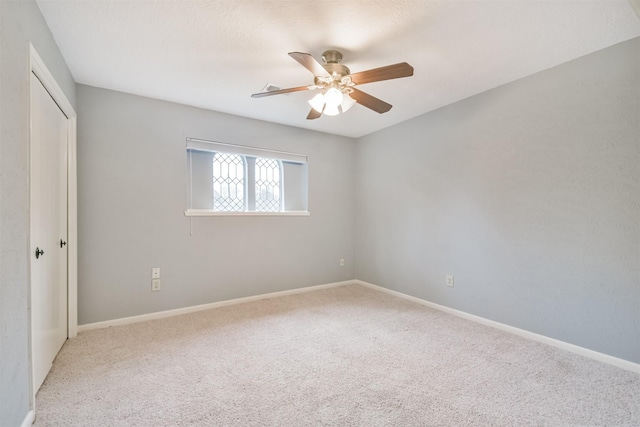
185,138,310,217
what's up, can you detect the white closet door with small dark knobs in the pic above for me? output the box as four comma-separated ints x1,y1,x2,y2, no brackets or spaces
30,73,68,390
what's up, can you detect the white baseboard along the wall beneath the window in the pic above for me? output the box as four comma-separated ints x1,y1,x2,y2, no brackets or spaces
78,280,356,332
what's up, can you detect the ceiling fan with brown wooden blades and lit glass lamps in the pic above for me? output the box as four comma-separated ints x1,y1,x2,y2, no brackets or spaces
251,50,413,120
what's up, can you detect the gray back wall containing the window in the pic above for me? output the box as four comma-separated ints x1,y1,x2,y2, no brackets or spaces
77,85,356,324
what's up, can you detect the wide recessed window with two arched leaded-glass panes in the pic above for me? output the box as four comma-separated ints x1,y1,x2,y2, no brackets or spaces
185,138,308,216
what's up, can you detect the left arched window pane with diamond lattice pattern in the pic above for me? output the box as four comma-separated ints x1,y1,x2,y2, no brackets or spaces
213,153,245,212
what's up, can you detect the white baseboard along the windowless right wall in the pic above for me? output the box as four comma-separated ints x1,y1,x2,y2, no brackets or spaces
353,280,640,374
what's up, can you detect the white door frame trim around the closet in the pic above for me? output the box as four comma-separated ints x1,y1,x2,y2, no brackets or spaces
26,43,78,400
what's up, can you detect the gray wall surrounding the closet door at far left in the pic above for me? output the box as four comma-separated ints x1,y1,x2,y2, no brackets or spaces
0,0,75,426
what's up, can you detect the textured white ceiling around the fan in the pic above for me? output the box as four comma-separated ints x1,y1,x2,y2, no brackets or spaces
38,0,640,137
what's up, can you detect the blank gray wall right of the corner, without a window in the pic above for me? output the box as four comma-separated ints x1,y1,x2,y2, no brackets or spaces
355,39,640,363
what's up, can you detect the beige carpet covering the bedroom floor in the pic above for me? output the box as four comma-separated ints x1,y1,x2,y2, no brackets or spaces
35,285,640,426
